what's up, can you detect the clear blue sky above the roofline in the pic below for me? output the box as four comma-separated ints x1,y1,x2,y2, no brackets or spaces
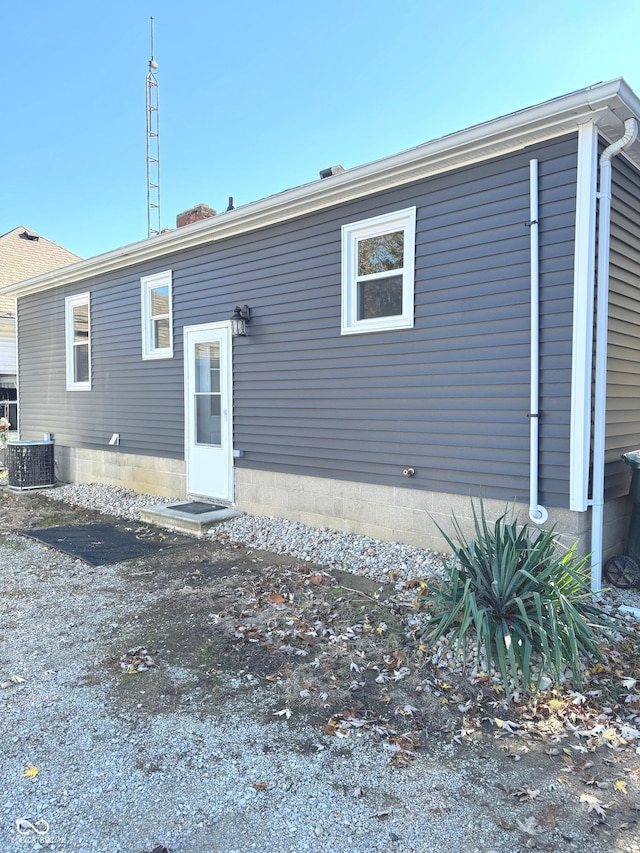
0,0,640,257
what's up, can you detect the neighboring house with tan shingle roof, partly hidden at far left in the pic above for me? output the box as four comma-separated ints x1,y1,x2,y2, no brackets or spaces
0,225,80,428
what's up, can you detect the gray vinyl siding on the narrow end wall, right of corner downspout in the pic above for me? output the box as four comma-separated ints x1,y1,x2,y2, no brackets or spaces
605,156,640,498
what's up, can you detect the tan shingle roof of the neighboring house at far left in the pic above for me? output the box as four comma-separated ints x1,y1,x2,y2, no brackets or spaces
0,225,81,316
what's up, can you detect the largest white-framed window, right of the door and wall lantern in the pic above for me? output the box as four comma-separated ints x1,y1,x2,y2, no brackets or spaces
341,207,416,335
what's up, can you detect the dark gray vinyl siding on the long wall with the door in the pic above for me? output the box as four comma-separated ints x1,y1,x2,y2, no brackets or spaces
19,134,577,506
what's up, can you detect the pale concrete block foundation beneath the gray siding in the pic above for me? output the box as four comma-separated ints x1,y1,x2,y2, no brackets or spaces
48,445,631,559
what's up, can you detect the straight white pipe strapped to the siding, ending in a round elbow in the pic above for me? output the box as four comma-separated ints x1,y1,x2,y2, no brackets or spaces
529,160,549,524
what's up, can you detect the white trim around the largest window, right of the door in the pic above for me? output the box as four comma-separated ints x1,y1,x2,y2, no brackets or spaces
341,207,416,335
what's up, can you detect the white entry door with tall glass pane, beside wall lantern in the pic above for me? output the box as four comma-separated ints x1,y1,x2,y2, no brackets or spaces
184,322,233,501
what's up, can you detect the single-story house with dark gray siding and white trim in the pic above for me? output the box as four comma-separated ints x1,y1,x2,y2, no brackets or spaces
6,80,640,585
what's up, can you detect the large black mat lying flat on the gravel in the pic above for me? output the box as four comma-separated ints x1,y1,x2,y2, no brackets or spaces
19,524,193,566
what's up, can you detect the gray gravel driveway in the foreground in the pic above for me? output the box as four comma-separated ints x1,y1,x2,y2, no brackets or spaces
0,490,640,853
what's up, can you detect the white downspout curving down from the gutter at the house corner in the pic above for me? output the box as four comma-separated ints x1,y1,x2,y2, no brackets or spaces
591,118,638,592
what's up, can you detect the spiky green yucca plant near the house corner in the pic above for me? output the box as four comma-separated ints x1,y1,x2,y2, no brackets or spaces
421,502,620,697
